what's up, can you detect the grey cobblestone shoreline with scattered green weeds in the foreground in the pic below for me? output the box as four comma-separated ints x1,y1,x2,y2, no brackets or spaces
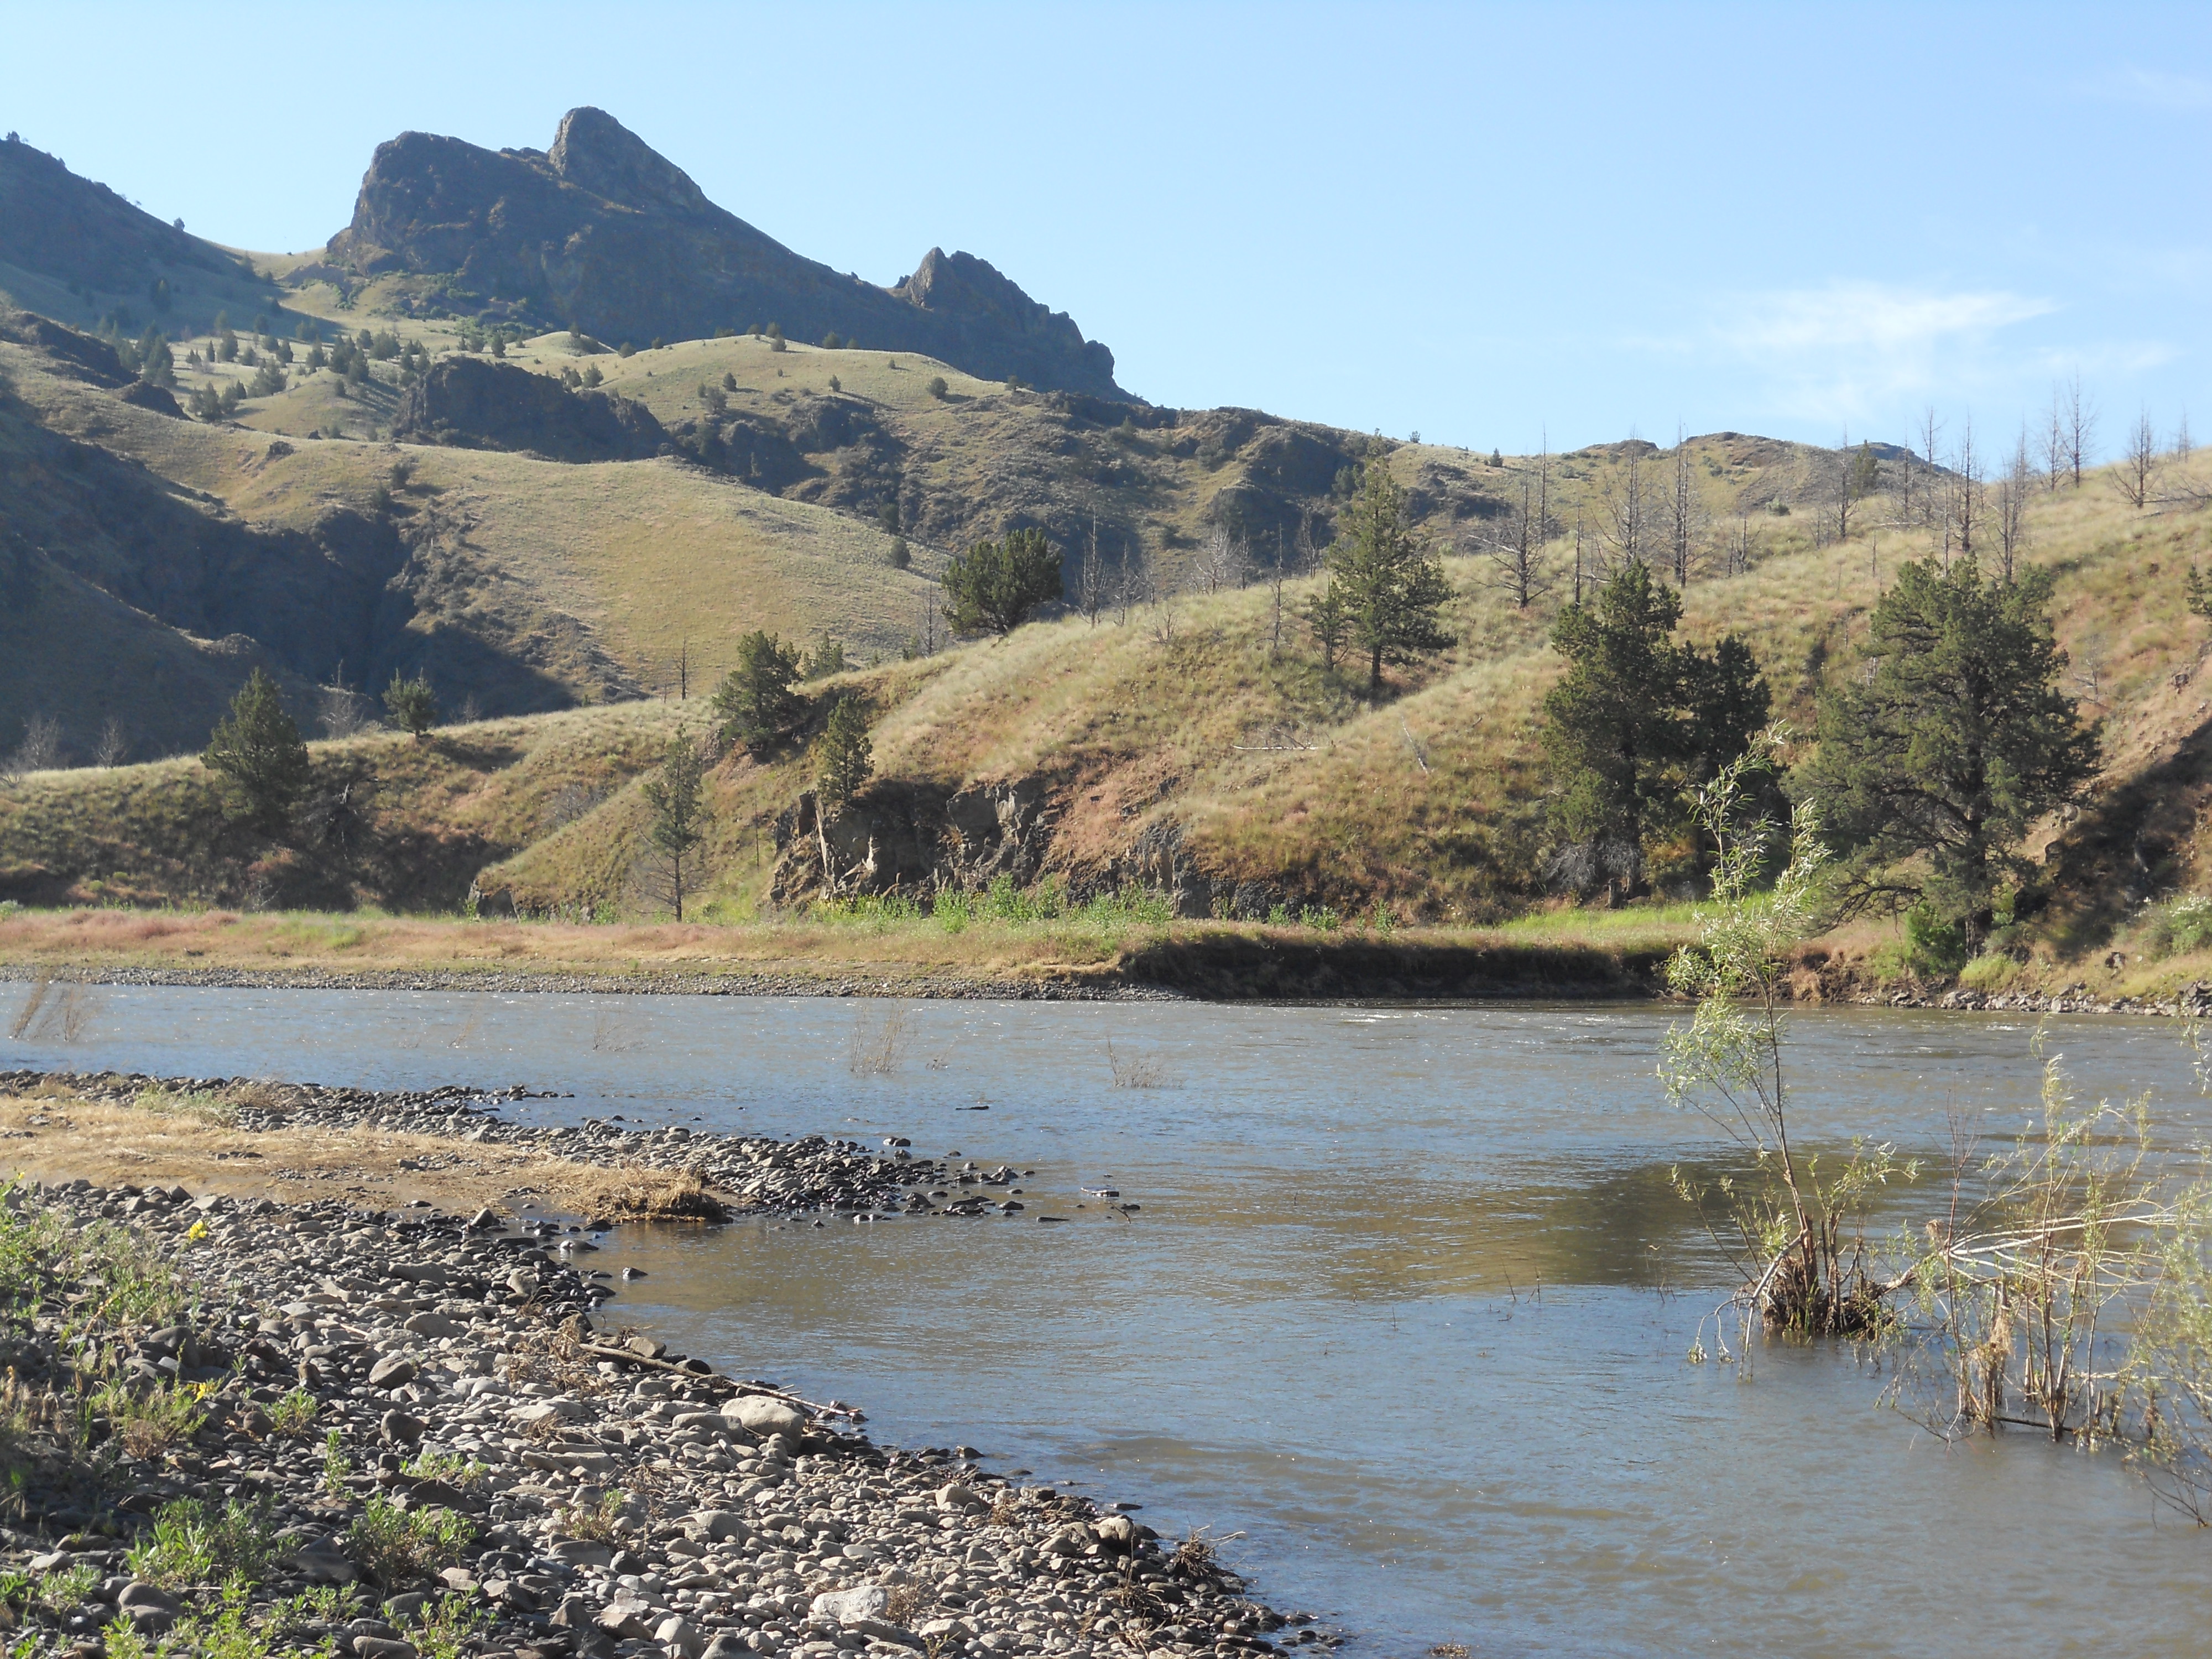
0,1073,1338,1659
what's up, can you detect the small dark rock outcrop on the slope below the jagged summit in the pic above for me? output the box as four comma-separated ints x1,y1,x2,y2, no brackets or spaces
392,356,668,460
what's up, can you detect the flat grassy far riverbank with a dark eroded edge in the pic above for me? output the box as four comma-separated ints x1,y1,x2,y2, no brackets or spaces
0,909,1694,1000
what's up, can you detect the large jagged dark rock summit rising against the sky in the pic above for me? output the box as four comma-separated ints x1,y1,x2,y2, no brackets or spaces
327,108,1126,398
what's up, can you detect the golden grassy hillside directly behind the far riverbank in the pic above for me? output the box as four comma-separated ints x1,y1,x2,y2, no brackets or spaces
0,436,2212,1000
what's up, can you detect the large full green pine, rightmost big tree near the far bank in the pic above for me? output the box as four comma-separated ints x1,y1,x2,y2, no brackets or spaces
1805,555,2099,951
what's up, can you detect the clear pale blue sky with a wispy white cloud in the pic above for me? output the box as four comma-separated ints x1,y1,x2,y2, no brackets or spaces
0,2,2212,451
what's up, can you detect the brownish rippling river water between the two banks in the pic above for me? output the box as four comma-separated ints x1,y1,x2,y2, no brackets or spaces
7,989,2212,1657
